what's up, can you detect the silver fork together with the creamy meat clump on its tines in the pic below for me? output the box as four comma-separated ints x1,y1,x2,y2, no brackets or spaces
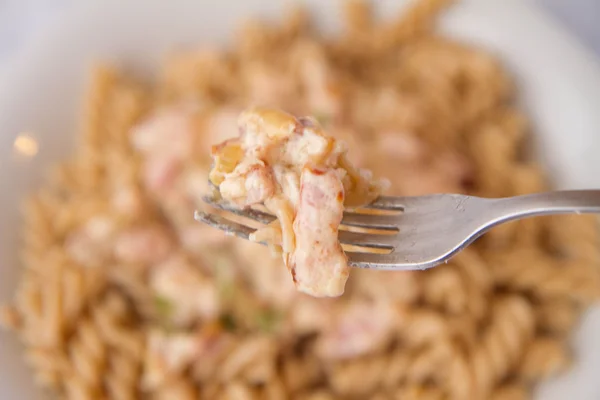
195,108,600,296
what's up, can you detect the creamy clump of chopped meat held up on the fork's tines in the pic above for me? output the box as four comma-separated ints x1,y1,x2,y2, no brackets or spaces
209,108,385,297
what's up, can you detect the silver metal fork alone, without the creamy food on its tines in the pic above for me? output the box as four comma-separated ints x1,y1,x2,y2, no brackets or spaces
195,190,600,270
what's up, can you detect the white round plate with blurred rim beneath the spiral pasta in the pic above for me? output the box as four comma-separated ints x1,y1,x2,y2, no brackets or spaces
0,0,600,400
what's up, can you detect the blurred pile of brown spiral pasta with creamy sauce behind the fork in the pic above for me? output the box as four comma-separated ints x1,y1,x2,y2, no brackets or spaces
1,0,600,400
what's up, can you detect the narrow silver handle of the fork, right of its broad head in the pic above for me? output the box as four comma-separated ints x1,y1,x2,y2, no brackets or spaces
492,190,600,223
